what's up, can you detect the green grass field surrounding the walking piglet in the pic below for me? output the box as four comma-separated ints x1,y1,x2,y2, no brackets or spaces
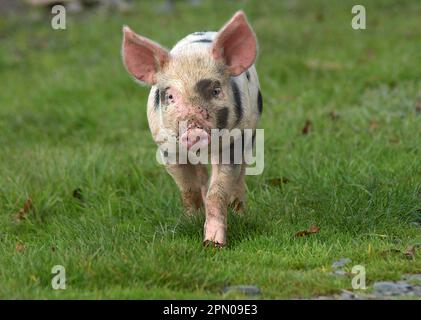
0,0,421,299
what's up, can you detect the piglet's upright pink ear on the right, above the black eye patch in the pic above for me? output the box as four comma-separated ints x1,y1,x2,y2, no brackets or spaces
212,11,257,76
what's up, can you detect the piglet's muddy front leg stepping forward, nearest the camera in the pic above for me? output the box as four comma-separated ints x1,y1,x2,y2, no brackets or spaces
203,164,241,247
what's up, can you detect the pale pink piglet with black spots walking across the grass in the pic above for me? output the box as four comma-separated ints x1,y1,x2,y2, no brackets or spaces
123,12,262,247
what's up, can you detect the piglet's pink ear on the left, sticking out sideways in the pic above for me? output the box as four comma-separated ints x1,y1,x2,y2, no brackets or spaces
123,27,169,85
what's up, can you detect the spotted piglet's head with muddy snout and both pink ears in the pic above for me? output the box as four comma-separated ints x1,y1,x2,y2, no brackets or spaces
123,11,257,147
